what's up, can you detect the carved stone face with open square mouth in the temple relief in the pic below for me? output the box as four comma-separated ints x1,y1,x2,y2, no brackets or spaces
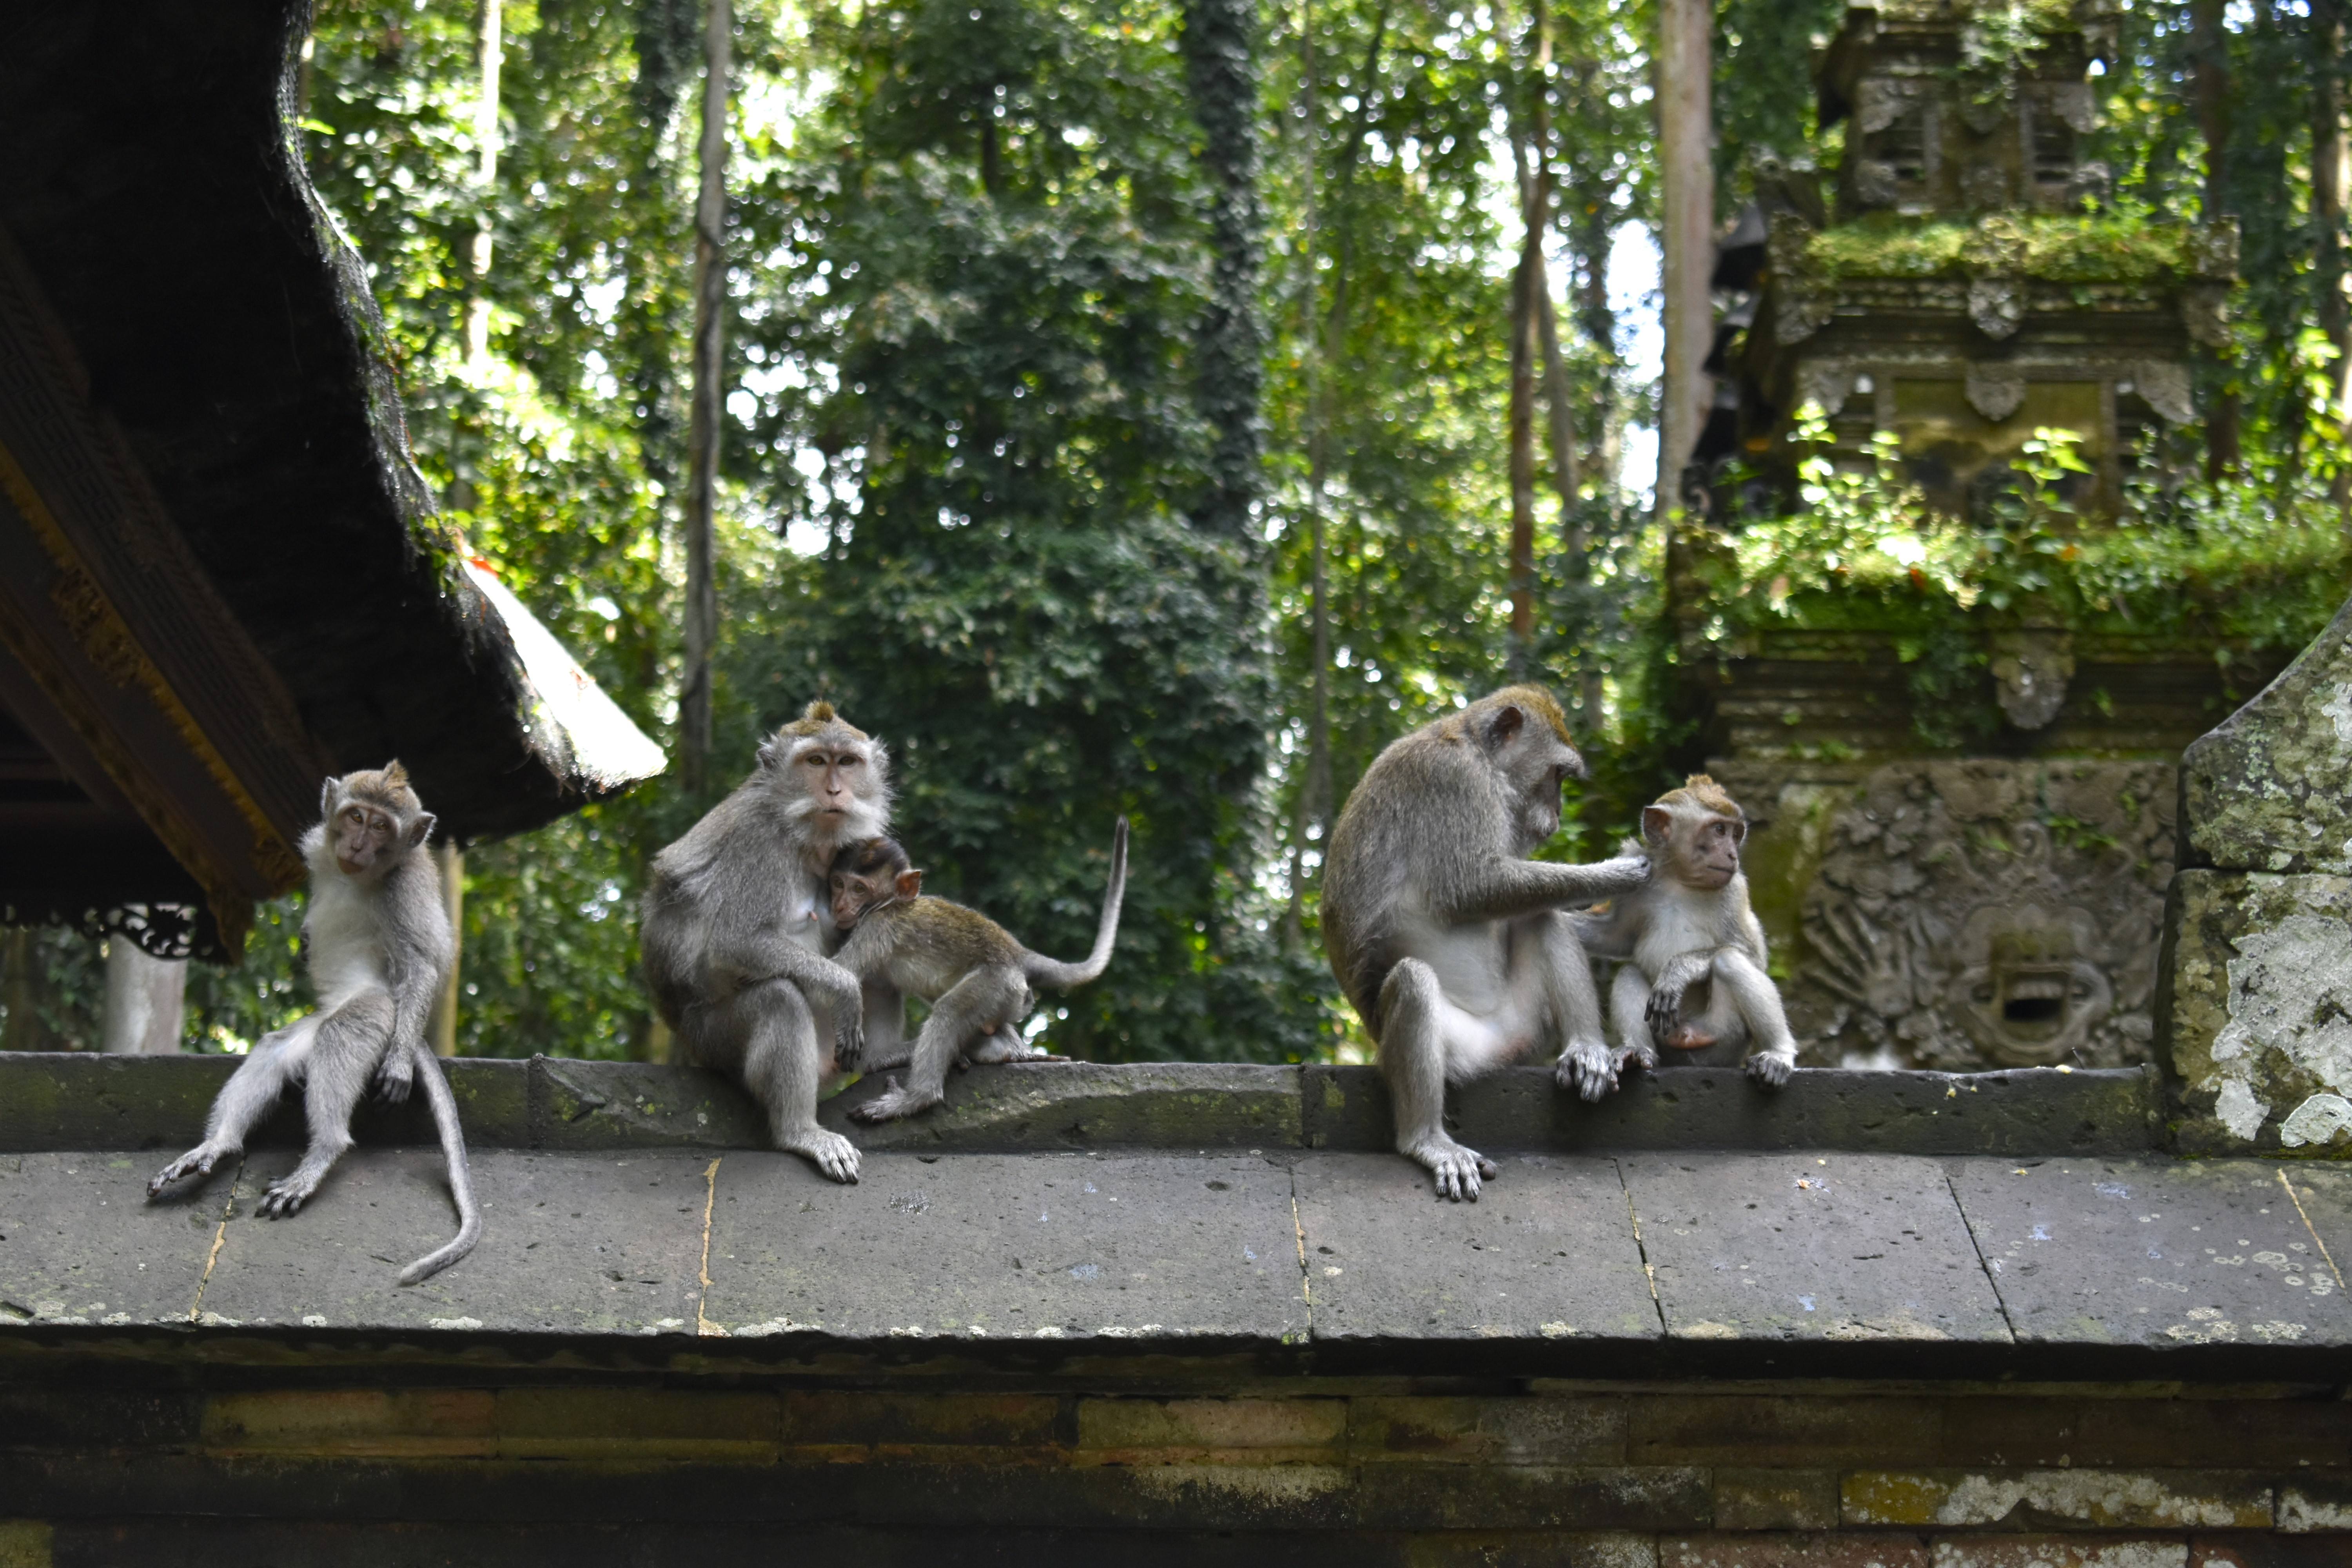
1945,905,2114,1067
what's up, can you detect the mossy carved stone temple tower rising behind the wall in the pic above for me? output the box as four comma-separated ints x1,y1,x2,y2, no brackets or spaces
1670,0,2272,1070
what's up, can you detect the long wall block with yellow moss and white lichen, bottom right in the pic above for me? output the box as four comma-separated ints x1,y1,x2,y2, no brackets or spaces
1842,1469,2272,1530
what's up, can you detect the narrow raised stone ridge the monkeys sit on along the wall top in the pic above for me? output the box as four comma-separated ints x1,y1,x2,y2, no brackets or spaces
0,1053,2161,1154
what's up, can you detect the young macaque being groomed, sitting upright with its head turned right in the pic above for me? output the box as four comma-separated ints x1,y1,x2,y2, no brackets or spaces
1576,773,1797,1089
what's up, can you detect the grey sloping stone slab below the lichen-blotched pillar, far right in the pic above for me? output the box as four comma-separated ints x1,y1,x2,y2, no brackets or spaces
1952,1159,2352,1345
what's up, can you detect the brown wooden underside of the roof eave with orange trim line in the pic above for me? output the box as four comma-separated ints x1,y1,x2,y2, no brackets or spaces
0,233,329,952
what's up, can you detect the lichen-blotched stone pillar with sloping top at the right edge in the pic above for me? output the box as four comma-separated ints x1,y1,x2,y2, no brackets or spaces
2157,604,2352,1157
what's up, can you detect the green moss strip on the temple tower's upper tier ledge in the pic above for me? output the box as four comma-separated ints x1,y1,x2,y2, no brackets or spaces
1802,214,2216,282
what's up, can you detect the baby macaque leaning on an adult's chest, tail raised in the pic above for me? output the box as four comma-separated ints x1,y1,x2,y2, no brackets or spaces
830,818,1127,1122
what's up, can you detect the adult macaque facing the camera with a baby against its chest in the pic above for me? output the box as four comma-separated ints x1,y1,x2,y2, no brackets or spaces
640,703,896,1182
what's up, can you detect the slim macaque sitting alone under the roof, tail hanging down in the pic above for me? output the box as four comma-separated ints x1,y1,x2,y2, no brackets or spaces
148,762,482,1286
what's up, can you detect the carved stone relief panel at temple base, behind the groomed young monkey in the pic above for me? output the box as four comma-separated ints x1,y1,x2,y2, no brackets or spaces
1783,759,2173,1072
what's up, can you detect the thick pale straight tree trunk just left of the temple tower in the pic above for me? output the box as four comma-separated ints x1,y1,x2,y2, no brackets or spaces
1656,0,1715,515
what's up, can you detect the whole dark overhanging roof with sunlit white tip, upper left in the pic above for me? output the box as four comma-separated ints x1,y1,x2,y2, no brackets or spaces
0,0,661,955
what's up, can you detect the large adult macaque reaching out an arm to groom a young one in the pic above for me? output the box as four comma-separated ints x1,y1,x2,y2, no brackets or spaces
1322,686,1649,1199
